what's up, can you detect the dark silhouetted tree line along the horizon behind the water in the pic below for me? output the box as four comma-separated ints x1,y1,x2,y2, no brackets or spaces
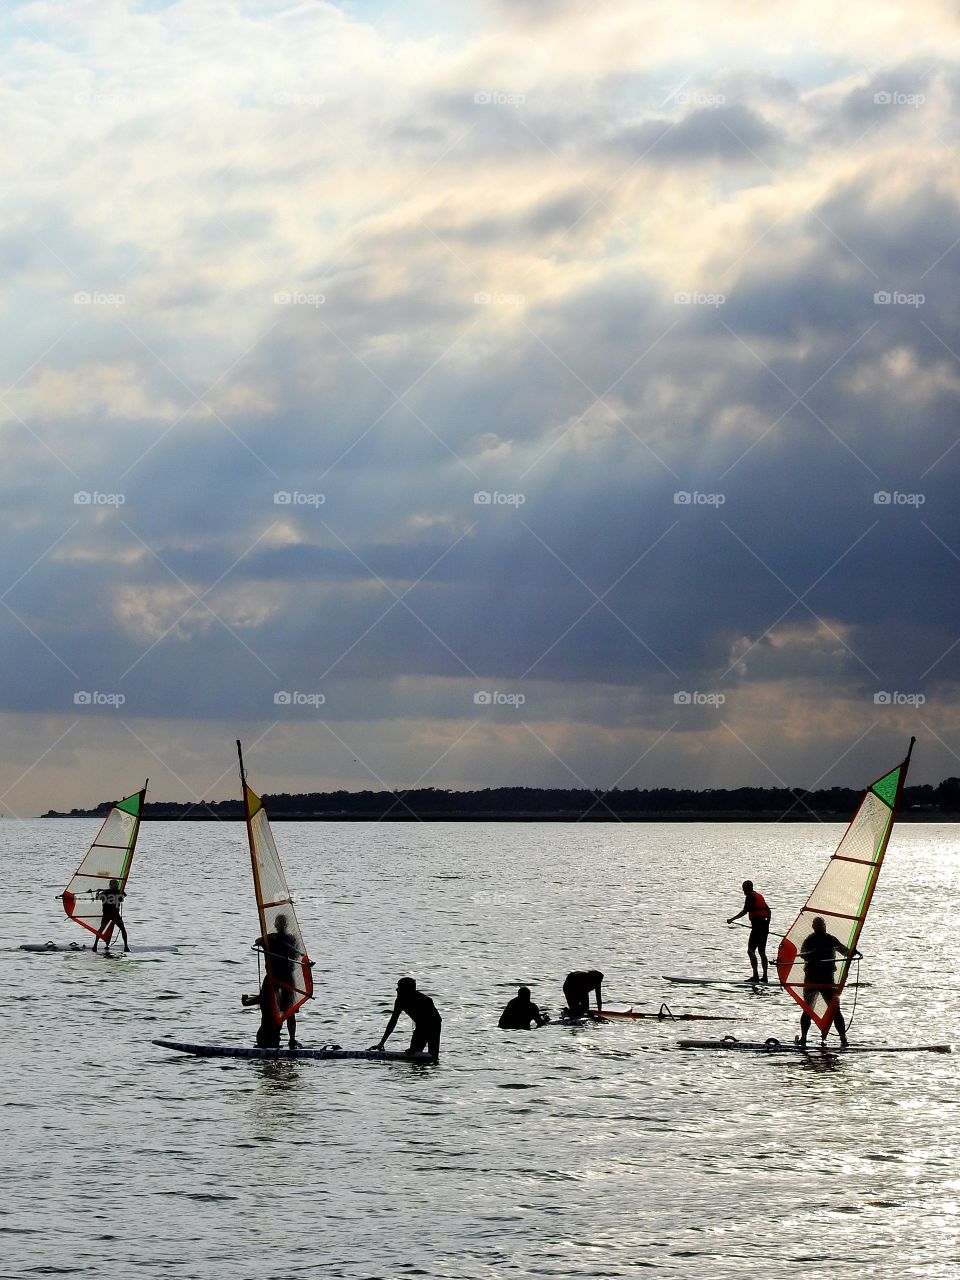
44,778,960,820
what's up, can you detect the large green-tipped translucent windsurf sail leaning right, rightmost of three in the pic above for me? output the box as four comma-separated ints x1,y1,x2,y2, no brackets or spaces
777,737,916,1036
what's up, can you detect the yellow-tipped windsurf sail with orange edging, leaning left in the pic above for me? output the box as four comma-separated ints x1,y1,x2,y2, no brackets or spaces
237,742,314,1027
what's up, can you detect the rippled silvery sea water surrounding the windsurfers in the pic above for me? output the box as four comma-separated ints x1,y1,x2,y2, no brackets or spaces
0,820,960,1280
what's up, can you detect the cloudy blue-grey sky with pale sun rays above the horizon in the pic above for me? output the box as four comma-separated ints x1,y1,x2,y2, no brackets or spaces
0,0,960,818
